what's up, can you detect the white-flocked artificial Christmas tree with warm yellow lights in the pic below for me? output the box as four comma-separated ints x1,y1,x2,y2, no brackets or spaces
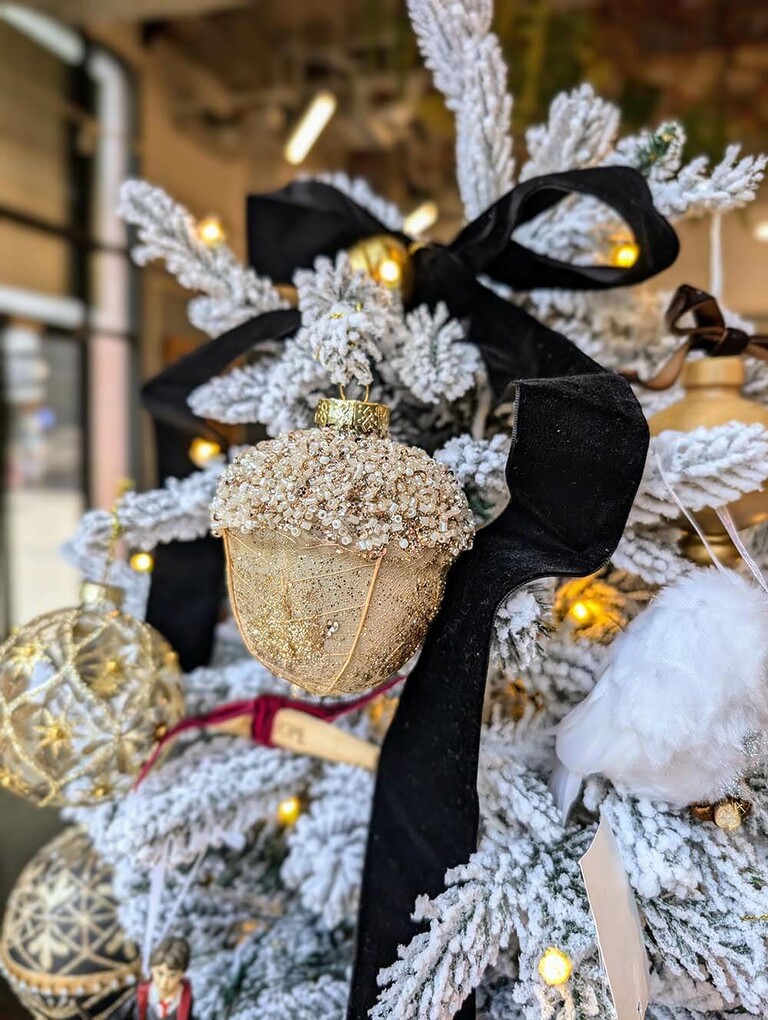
1,0,768,1020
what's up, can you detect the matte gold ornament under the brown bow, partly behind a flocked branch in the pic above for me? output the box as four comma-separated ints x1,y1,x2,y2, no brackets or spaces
649,356,768,566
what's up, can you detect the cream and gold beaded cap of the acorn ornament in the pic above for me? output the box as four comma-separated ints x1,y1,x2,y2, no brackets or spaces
211,428,474,556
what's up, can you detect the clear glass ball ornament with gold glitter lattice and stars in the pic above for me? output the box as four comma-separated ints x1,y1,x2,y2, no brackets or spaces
0,584,184,807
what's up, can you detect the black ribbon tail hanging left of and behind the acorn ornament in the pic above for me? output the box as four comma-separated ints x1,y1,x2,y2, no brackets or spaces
142,309,299,671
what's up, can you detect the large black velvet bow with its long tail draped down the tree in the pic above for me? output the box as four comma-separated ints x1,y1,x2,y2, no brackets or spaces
137,167,678,1020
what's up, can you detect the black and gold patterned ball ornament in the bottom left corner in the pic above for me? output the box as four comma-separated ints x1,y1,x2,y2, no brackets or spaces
0,826,141,1020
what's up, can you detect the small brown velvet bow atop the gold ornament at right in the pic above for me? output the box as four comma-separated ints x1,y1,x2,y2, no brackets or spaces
621,284,768,390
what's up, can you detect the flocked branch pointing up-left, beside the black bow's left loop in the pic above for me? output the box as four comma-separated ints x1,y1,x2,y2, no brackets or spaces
118,181,287,337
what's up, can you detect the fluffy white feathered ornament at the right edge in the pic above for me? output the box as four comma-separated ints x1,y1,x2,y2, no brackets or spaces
550,568,768,815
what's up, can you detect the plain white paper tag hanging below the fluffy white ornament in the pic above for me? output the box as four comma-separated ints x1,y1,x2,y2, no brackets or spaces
578,818,649,1020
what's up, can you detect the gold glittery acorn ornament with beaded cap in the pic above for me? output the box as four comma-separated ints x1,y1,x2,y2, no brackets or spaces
212,400,473,695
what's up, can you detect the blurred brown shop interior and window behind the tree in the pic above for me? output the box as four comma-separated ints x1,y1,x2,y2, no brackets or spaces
0,0,768,1003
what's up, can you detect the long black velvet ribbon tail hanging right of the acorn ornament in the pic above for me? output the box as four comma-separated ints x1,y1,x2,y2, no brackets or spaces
348,285,648,1020
